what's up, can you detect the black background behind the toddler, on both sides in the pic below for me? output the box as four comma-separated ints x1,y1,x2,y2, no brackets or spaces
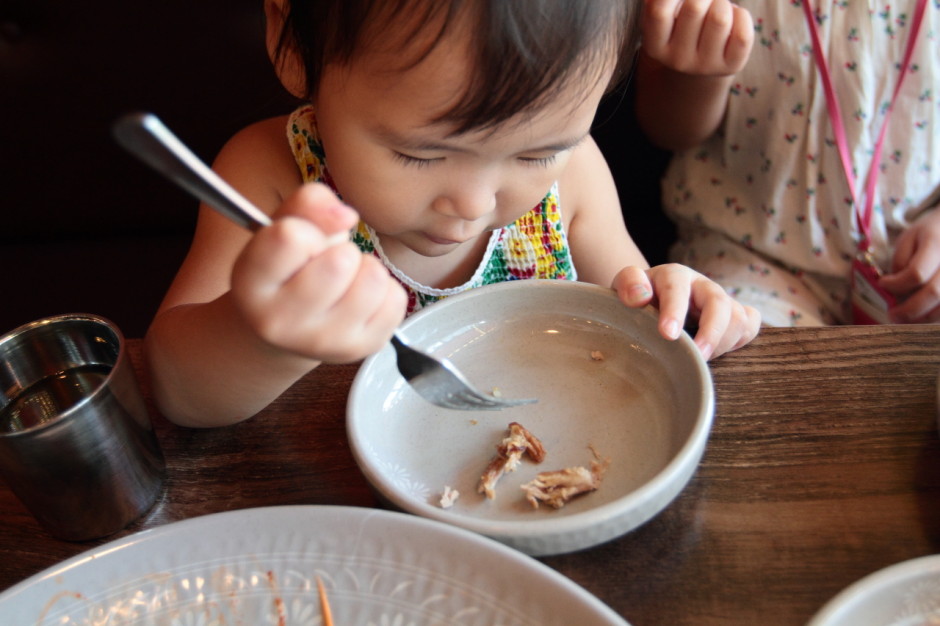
0,0,673,337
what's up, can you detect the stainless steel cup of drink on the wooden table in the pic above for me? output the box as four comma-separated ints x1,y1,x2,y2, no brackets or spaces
0,314,165,541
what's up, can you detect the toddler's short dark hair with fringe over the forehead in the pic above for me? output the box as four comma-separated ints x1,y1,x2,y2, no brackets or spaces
276,0,641,134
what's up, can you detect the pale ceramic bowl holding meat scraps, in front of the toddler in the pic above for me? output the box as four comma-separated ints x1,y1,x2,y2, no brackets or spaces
347,280,714,555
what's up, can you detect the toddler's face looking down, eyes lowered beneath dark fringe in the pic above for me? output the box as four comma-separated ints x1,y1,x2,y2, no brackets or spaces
315,17,609,266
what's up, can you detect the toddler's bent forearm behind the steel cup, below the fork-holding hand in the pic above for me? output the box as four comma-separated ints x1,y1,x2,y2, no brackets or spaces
145,294,318,427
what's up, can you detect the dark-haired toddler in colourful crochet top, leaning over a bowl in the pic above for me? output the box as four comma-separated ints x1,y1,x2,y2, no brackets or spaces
146,0,760,426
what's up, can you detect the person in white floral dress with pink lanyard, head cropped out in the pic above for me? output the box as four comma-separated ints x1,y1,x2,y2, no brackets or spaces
636,0,940,326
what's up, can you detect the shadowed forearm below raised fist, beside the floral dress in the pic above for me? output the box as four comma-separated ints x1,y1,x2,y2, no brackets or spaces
635,52,734,151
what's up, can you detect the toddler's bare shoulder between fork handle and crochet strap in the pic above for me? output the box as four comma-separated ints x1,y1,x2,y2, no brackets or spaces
212,115,302,212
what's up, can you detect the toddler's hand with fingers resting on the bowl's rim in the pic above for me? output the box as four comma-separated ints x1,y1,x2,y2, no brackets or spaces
613,263,760,359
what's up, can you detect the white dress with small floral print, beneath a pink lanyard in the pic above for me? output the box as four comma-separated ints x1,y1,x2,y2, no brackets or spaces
663,0,940,326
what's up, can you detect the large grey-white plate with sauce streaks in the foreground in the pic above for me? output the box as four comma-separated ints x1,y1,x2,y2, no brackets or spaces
0,506,629,626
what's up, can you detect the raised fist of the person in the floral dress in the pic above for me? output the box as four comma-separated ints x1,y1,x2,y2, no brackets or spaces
640,0,754,76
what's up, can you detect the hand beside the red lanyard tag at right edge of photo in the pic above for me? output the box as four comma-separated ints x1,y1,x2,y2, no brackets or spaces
881,207,940,324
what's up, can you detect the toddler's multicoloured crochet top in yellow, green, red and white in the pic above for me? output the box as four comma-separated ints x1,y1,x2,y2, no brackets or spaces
287,105,577,315
